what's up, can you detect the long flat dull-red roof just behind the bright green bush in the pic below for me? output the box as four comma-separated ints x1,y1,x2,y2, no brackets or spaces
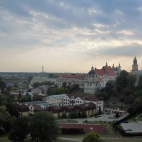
59,123,106,134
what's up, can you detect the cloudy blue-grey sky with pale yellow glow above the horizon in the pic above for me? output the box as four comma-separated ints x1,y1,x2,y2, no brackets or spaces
0,0,142,73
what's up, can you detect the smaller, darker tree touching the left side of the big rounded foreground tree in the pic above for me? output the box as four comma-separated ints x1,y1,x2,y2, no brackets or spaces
9,117,29,142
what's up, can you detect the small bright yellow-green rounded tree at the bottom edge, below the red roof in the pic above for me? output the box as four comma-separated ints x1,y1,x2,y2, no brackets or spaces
83,131,101,142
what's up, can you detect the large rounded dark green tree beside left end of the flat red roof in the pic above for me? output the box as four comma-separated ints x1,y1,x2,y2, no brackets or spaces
29,112,60,142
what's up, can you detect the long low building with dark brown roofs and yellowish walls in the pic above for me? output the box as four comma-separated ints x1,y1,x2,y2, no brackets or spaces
12,101,96,117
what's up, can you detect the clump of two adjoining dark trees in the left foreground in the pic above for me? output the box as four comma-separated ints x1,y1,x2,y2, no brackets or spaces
9,112,60,142
